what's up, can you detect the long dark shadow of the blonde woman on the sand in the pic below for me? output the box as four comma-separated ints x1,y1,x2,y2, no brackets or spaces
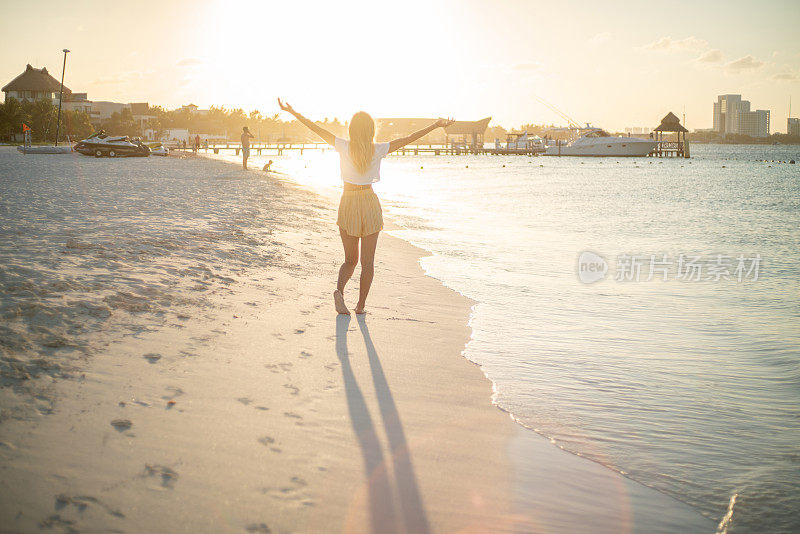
336,315,430,534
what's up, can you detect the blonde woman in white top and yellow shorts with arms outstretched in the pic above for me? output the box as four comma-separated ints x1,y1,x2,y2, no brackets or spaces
278,98,453,314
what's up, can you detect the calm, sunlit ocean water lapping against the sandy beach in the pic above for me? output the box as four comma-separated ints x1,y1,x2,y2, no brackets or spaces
236,145,800,533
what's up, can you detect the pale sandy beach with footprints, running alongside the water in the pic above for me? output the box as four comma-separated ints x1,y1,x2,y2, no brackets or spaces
0,147,714,533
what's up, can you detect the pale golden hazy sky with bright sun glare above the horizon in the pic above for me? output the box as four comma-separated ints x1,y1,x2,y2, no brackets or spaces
0,0,800,132
